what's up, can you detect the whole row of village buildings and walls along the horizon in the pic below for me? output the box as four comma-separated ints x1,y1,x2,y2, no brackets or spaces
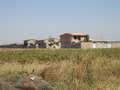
0,33,120,49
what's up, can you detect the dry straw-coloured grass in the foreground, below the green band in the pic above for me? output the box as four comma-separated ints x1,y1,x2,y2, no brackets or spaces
0,59,120,90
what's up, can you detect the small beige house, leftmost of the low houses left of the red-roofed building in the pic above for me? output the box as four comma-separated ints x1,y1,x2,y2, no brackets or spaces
24,39,37,48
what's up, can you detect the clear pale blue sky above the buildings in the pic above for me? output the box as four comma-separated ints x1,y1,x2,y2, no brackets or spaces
0,0,120,44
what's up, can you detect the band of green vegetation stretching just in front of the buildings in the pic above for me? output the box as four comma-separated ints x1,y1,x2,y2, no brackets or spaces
0,48,120,63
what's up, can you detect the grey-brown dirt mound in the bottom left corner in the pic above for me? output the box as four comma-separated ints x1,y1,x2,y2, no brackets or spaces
0,73,55,90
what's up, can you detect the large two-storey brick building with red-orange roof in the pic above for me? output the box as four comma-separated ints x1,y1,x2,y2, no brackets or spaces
60,33,89,48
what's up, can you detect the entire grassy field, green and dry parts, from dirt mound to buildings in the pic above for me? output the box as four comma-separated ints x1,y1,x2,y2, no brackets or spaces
0,48,120,90
